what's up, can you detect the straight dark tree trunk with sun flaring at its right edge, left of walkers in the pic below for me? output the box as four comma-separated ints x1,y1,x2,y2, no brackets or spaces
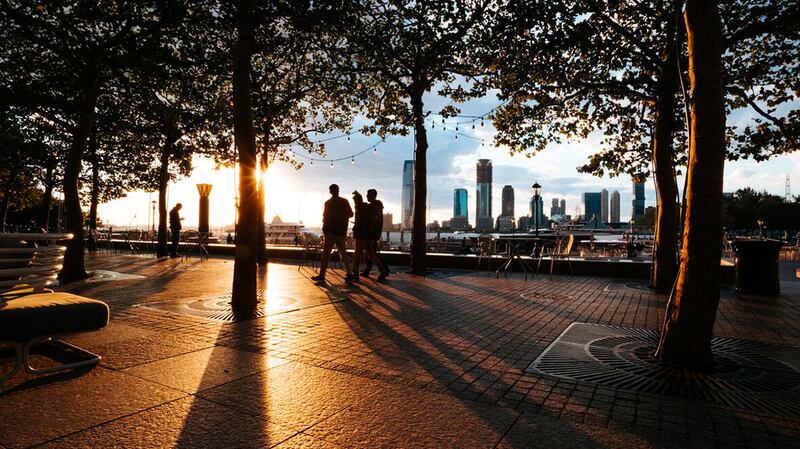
231,0,259,316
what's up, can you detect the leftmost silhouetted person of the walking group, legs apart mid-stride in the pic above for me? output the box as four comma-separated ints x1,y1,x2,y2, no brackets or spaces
311,184,353,283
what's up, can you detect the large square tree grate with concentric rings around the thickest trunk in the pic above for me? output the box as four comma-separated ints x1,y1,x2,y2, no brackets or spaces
526,323,800,416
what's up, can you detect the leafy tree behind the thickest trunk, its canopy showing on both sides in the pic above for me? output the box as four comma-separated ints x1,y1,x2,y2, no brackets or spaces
495,1,798,291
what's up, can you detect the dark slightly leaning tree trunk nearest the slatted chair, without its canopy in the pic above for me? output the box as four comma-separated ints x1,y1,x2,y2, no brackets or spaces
58,72,97,283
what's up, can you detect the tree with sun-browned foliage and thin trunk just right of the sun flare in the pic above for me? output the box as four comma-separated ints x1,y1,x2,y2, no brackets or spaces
238,2,355,264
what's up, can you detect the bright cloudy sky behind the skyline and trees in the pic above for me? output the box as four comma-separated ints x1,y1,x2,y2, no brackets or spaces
99,93,800,229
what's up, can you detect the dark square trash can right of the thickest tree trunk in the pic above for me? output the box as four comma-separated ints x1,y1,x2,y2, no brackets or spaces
730,239,783,296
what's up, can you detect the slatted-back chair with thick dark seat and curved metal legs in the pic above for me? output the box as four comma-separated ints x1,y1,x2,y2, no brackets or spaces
0,234,109,382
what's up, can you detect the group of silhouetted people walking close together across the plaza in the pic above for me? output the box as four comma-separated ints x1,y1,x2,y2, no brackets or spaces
311,184,389,284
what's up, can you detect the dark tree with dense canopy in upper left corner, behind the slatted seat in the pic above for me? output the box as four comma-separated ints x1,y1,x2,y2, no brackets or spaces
0,0,182,282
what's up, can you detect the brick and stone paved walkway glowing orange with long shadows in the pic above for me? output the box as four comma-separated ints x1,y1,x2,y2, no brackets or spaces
0,255,800,449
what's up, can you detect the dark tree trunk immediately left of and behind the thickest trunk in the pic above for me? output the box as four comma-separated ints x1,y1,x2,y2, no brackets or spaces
650,19,679,293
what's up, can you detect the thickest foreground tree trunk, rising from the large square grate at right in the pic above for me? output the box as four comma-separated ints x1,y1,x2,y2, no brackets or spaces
656,0,725,370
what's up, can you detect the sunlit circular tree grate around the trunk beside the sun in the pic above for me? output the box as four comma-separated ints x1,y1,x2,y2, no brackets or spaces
138,290,347,322
